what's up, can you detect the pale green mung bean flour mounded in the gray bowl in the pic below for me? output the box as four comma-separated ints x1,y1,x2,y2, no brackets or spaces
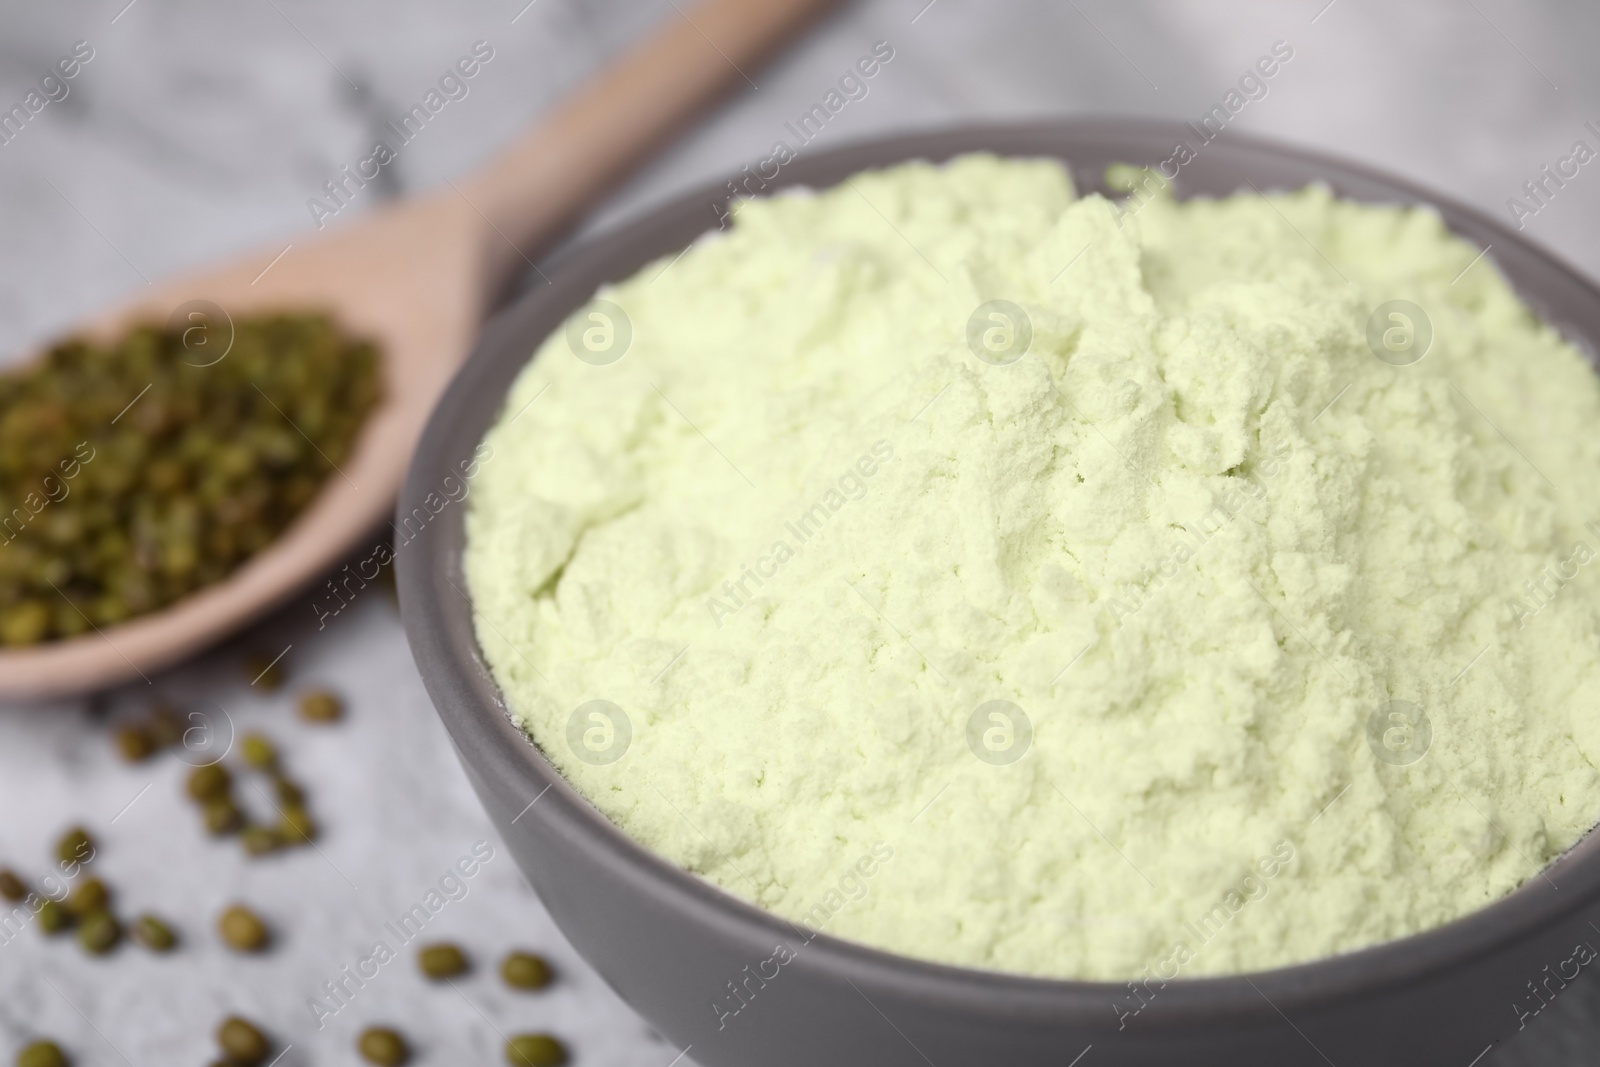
466,155,1600,979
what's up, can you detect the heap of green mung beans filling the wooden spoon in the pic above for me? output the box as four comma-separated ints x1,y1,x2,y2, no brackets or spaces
0,314,381,646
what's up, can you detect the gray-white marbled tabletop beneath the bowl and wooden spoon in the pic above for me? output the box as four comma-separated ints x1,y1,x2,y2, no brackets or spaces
0,0,1600,1067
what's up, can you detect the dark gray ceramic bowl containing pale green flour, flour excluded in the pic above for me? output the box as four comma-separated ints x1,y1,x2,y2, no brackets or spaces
397,120,1600,1067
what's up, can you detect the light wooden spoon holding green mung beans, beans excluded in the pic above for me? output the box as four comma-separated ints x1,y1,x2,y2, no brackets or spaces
0,0,832,697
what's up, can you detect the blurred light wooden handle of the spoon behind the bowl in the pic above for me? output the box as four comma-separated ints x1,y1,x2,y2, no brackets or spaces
461,0,837,295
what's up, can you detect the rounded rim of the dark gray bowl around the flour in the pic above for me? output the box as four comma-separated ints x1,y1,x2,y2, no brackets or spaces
395,117,1600,1032
